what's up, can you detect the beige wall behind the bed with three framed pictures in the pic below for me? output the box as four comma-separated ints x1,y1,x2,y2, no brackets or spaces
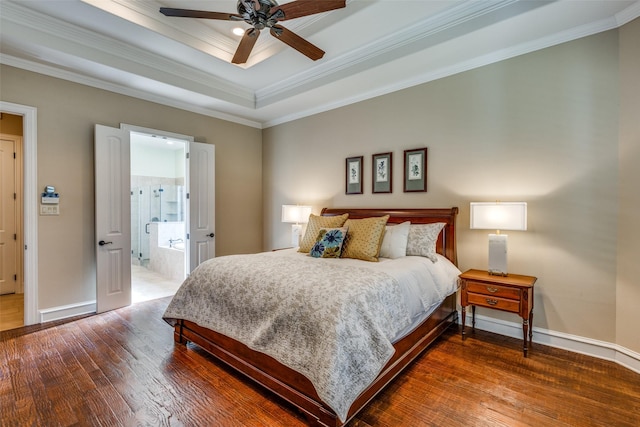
263,30,640,351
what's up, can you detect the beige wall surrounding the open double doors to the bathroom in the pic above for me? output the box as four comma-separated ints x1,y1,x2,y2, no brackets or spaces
0,66,263,309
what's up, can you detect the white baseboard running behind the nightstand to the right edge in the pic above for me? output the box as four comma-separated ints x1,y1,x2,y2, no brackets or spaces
460,313,640,374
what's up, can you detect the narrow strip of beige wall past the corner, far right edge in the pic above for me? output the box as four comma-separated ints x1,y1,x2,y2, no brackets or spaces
616,19,640,352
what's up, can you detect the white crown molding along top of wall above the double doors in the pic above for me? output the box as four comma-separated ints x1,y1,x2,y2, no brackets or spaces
0,54,262,129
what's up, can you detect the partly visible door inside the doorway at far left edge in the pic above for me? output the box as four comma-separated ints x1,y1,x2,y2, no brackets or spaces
0,136,18,295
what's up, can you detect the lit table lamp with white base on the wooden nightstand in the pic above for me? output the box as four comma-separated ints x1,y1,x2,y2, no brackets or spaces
470,202,527,276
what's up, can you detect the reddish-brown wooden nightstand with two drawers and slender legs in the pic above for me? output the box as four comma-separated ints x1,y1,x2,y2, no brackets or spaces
460,270,538,357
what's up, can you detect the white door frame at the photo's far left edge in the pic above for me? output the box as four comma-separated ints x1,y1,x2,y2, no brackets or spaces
0,101,39,326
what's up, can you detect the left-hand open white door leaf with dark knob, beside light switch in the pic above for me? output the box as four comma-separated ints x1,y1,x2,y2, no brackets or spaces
94,125,131,313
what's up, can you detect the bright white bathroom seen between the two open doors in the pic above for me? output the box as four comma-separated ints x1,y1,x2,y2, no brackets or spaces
131,132,186,302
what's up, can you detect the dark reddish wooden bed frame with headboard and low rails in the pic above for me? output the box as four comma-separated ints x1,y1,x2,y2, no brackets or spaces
174,207,458,427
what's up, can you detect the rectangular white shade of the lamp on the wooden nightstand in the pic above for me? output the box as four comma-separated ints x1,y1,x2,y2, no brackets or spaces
470,202,527,231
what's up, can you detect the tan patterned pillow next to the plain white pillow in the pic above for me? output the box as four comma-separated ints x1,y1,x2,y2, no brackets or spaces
342,215,389,261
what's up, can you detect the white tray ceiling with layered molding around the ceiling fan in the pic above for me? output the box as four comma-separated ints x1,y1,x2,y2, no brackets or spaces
0,0,640,128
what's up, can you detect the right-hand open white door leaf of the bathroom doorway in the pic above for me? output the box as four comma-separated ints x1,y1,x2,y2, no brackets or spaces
187,142,216,272
